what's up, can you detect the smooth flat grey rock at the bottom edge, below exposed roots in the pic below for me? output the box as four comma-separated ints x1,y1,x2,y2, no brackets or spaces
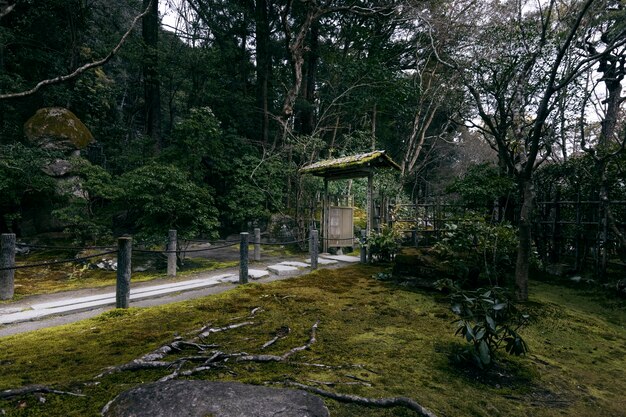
102,381,330,417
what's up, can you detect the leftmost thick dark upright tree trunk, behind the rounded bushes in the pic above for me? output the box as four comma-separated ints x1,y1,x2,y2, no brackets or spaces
141,0,162,150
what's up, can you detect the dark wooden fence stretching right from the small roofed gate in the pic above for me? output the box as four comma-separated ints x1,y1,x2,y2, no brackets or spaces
375,198,626,279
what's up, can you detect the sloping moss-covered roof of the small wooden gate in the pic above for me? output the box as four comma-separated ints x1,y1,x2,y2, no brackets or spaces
300,151,400,178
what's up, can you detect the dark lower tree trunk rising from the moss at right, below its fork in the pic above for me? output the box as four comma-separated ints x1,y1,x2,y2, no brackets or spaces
515,178,535,301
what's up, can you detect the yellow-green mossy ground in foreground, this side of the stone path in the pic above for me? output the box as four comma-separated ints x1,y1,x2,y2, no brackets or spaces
0,266,626,417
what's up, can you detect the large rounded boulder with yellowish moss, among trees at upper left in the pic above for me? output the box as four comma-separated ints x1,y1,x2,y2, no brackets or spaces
24,107,94,152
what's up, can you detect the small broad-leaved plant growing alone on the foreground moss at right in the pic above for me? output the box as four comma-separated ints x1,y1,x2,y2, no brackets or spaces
438,280,529,369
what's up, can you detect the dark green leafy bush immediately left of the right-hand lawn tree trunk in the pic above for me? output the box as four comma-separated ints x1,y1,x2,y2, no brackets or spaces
433,214,517,284
